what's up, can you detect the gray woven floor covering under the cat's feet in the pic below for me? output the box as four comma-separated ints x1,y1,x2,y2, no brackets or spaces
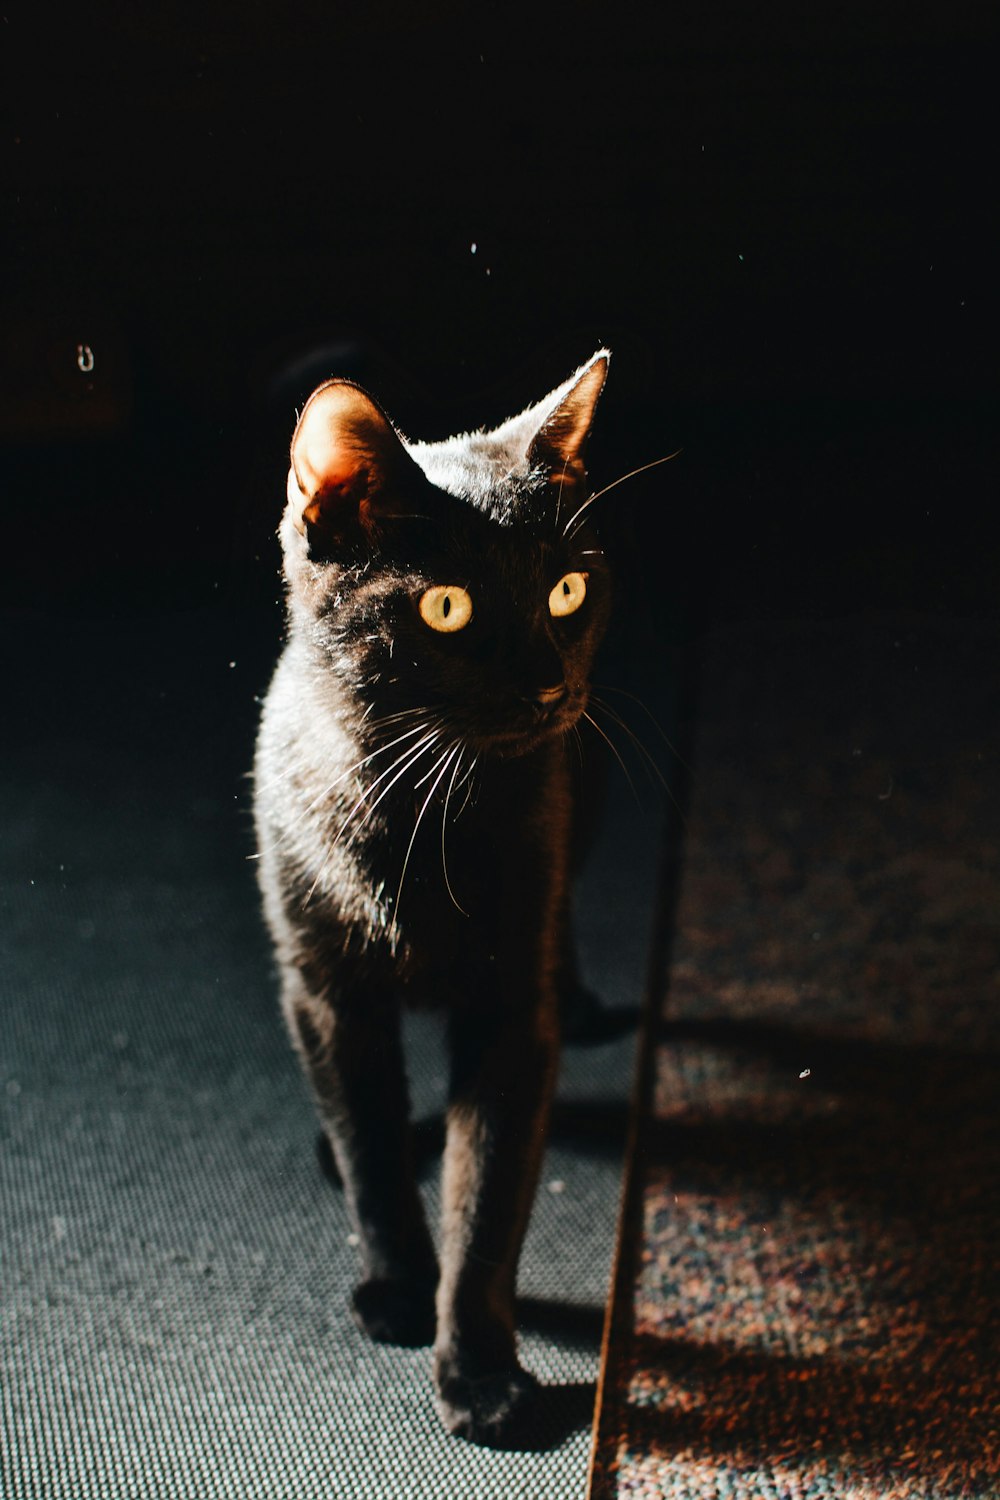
0,611,671,1500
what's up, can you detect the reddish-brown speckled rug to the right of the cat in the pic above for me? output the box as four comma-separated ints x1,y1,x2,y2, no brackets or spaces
592,618,1000,1500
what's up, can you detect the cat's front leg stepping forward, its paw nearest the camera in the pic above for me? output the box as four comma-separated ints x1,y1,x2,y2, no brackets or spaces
435,989,558,1446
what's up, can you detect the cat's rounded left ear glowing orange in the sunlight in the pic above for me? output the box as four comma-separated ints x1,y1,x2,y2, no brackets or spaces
288,380,418,555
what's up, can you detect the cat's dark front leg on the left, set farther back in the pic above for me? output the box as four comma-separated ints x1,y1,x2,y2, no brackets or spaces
283,975,438,1346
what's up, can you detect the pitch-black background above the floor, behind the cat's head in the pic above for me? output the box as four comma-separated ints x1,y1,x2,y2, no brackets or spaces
0,0,999,648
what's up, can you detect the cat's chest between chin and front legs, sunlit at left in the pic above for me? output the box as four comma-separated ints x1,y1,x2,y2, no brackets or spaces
258,650,574,1004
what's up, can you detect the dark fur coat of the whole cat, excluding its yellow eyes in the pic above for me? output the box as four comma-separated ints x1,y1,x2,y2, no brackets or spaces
255,351,610,1443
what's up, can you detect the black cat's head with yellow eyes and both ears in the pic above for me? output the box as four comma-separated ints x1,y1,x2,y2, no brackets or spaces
280,350,610,755
